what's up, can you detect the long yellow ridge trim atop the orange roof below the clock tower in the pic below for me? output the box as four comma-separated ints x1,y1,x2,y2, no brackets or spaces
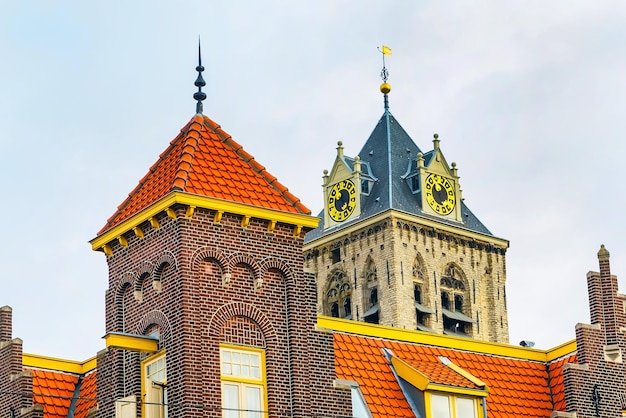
317,315,576,363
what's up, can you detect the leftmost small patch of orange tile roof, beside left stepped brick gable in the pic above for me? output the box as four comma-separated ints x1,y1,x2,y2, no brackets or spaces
27,369,78,418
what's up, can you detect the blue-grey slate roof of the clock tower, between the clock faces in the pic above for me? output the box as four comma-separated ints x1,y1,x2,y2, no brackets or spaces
305,109,493,242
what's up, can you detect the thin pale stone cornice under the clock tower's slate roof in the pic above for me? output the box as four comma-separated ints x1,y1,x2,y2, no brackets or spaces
304,209,509,251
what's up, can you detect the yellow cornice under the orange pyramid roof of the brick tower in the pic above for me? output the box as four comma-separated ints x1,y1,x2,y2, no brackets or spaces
89,192,319,251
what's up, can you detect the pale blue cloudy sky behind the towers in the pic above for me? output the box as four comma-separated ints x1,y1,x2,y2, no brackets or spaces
0,0,626,360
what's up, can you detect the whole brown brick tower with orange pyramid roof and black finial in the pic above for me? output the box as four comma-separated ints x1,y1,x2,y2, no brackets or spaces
91,51,351,418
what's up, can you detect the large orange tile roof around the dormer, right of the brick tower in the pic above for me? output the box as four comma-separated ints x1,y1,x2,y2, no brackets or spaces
334,333,553,418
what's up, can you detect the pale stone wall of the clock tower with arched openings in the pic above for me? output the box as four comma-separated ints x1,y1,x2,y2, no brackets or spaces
305,218,509,343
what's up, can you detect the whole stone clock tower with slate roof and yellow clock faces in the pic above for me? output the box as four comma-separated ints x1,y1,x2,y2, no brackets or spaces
304,60,509,343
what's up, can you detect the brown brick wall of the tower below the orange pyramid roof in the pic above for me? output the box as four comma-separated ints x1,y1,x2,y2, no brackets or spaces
98,208,350,417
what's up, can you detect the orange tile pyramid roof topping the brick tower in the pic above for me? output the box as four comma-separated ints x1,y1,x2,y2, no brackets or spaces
98,115,311,235
